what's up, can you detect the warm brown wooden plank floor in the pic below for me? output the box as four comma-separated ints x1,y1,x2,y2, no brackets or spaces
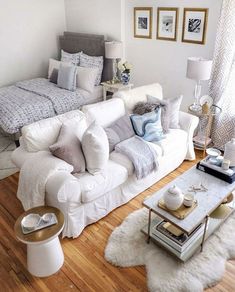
0,154,235,292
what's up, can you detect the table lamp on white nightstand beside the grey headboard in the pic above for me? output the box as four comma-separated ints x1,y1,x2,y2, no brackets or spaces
105,41,122,83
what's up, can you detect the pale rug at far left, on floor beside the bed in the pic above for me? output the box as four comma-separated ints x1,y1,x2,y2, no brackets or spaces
0,132,19,180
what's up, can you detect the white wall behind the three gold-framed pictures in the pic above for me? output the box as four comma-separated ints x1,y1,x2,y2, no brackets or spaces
125,0,222,109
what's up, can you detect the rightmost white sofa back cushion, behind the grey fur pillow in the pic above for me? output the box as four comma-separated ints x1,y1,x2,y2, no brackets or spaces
113,83,163,114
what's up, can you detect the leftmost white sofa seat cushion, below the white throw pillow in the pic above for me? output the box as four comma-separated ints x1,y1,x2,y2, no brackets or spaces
74,160,128,203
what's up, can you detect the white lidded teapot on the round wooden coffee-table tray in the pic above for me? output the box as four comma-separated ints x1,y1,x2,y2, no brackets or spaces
163,185,184,211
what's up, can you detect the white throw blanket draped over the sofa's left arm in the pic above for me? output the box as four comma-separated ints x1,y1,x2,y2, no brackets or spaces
17,151,73,210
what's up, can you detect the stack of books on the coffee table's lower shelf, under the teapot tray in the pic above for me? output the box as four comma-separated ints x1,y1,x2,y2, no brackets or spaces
152,220,205,256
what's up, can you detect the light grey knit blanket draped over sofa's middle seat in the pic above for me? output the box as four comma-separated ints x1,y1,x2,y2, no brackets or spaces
115,136,158,180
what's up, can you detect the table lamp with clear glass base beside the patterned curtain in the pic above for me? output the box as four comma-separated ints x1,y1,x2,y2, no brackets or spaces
186,57,212,112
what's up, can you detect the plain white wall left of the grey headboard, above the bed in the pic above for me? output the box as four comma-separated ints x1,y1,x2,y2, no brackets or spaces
0,0,66,86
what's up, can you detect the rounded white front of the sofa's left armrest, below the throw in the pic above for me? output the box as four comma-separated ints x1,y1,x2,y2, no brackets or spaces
46,171,81,204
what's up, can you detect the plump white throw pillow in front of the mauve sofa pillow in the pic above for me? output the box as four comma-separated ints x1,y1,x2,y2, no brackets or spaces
82,122,109,175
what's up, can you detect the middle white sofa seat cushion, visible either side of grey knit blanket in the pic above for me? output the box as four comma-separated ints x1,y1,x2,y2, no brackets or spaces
109,142,163,176
